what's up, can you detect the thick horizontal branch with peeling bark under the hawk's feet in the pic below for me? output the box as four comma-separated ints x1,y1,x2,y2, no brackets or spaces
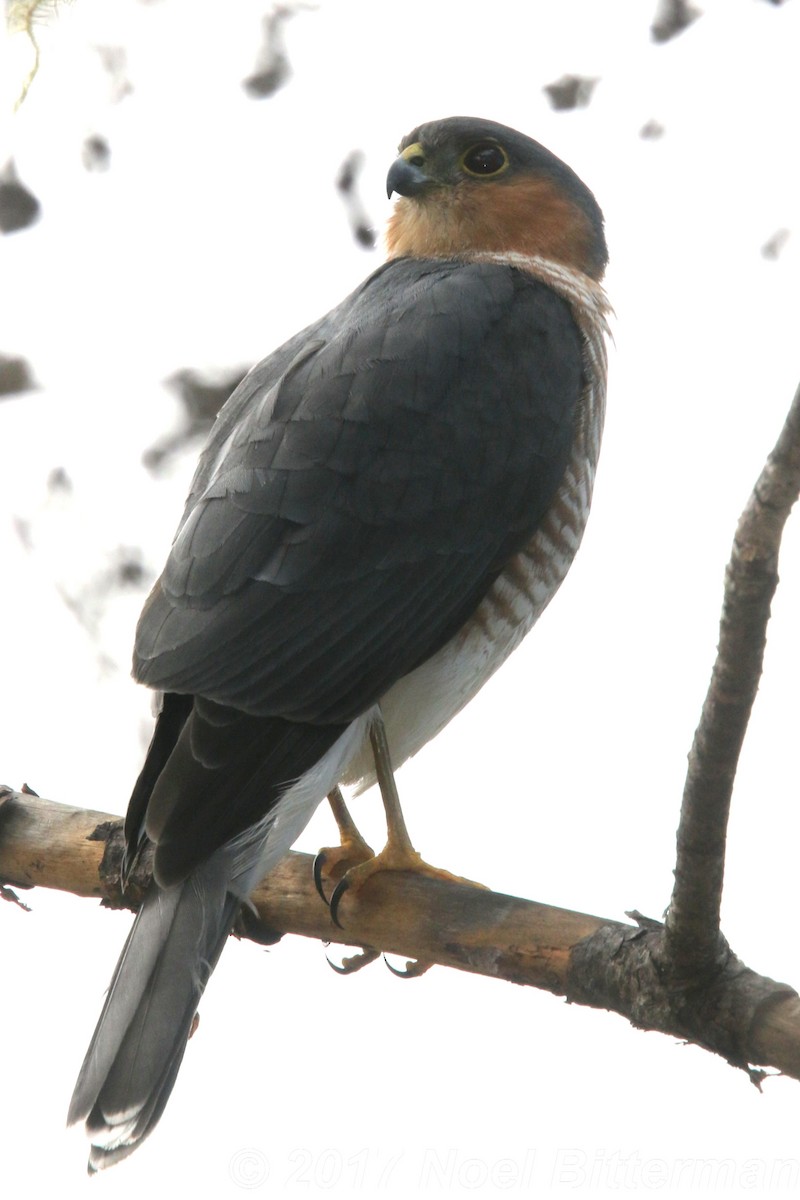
0,791,800,1079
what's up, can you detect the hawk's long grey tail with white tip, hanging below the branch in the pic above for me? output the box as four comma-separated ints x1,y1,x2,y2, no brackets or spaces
68,850,240,1174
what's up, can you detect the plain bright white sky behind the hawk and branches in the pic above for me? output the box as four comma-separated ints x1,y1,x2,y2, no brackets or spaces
0,0,800,1200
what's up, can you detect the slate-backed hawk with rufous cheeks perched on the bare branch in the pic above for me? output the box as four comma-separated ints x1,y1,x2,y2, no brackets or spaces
70,116,608,1170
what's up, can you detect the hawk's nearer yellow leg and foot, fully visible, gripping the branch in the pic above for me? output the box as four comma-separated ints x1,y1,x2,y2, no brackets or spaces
330,712,481,928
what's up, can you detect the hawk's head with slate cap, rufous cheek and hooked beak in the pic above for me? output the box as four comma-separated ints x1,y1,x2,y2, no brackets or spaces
386,116,608,280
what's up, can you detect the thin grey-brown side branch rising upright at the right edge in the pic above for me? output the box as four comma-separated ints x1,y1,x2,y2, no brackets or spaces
667,388,800,974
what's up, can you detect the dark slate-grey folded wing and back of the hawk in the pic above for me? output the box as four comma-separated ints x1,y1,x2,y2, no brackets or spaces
134,259,583,724
